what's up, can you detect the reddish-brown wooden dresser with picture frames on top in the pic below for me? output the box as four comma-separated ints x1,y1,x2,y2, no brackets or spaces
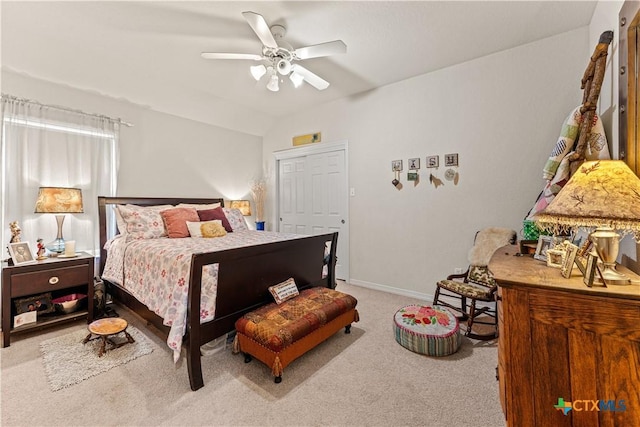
489,246,640,427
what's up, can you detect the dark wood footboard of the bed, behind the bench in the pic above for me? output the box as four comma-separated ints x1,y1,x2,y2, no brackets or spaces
185,233,338,390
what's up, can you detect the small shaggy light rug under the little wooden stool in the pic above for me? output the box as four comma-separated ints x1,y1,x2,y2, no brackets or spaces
40,326,153,391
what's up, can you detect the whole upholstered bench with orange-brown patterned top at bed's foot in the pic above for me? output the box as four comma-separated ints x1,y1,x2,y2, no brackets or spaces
234,287,359,383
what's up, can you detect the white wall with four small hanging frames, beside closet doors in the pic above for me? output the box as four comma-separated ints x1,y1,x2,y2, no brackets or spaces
264,27,590,298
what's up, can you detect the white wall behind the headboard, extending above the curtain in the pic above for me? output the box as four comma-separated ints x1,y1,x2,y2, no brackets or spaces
2,70,263,205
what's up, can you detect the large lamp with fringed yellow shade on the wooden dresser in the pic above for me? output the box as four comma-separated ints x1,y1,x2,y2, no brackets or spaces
535,160,640,285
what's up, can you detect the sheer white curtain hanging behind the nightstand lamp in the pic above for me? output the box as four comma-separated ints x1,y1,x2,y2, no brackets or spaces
0,95,120,259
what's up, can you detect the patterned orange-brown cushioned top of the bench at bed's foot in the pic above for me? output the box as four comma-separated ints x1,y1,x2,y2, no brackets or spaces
236,287,358,352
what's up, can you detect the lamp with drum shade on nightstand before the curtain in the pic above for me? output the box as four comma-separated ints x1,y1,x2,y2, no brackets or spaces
35,187,84,256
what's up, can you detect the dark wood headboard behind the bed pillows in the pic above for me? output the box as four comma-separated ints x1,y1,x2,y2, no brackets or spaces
98,196,224,276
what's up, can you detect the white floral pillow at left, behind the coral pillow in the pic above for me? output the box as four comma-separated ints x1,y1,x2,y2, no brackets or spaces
118,205,173,241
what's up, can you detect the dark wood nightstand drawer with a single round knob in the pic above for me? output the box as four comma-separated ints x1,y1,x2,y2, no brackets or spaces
11,264,89,297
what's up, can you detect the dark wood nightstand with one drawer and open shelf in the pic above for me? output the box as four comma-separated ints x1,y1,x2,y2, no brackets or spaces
2,253,94,347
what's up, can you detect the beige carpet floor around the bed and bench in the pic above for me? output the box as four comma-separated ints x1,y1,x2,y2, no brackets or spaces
0,283,505,427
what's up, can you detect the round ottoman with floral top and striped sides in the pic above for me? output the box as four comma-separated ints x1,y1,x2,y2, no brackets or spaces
393,305,461,356
